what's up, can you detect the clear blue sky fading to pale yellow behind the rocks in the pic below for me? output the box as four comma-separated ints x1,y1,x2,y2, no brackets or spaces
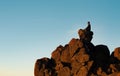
0,0,120,76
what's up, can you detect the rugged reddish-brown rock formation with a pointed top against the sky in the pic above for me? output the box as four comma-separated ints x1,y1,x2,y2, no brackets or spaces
34,22,120,76
